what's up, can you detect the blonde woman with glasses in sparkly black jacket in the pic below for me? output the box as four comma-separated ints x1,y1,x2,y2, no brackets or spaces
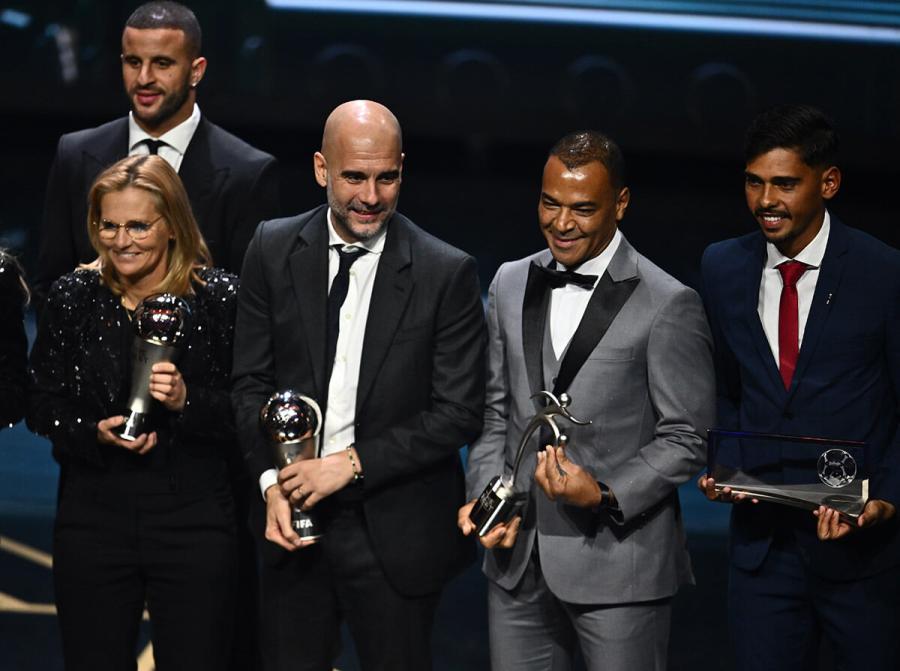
26,156,237,671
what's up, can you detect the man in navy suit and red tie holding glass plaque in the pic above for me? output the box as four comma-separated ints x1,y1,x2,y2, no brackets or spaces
700,106,900,671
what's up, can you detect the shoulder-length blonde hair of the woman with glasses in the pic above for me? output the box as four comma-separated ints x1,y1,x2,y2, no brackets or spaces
87,155,212,296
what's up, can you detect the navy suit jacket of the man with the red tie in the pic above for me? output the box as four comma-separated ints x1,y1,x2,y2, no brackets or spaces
702,217,900,579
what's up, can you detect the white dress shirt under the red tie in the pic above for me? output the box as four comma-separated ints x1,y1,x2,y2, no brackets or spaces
757,210,831,364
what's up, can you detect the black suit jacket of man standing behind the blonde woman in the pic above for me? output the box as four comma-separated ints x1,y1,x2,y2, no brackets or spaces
34,117,280,309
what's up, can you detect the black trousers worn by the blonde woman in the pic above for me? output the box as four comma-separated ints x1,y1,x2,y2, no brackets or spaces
53,481,236,671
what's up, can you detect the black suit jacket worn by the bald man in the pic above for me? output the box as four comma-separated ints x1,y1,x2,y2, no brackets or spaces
233,206,485,595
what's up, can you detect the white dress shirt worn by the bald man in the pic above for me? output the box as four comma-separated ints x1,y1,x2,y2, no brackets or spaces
259,208,387,498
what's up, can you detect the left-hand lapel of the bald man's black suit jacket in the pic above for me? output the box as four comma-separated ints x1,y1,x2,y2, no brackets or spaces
288,207,328,405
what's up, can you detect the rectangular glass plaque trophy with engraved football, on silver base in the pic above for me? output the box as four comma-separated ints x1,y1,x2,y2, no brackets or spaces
708,429,869,521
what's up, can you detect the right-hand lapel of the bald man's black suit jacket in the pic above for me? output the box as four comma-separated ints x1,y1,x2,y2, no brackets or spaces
356,214,413,417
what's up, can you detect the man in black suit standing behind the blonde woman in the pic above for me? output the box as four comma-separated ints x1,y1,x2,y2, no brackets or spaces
34,2,278,307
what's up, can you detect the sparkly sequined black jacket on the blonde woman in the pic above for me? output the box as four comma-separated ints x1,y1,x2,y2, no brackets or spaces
25,268,237,499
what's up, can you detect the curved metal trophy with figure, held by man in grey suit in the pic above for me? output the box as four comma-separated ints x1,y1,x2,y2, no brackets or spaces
469,391,590,537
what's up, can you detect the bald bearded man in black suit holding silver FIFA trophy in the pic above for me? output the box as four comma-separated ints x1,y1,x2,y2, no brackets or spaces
233,101,485,671
